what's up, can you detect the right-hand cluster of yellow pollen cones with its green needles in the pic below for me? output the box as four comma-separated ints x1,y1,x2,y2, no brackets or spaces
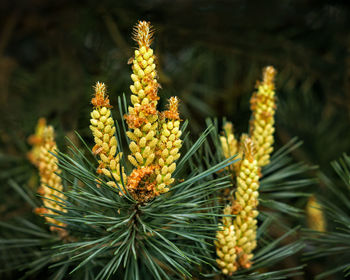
202,66,314,279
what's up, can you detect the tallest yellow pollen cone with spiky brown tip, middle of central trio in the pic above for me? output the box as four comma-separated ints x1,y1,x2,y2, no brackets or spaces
125,21,159,171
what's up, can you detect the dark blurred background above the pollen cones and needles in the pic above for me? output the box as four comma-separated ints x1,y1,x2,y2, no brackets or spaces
0,0,350,278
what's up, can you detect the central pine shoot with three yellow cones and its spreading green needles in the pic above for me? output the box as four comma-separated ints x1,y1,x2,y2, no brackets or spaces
52,22,238,279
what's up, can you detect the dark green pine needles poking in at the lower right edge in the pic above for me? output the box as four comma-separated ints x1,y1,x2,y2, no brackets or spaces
306,154,350,279
